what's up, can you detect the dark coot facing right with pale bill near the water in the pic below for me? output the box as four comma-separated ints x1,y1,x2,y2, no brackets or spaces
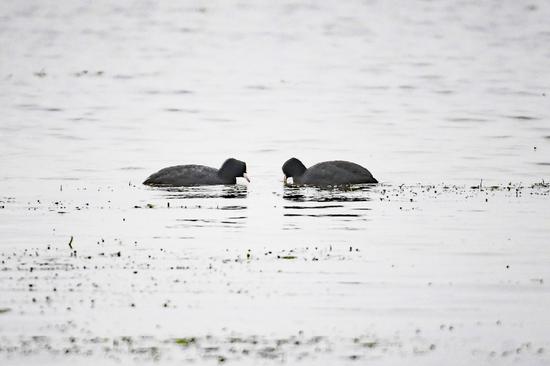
143,158,250,187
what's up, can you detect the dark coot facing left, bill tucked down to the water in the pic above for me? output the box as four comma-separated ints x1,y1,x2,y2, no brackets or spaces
283,158,378,186
